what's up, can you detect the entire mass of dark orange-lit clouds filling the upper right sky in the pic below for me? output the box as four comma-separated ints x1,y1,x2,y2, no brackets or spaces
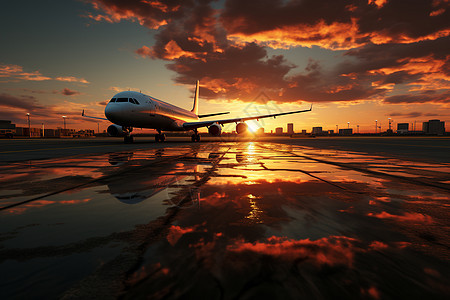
90,0,450,103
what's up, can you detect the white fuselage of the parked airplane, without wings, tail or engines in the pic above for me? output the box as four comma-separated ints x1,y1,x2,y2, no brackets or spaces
105,91,199,131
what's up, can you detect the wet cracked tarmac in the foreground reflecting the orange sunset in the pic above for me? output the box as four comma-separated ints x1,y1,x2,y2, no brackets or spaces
0,141,450,299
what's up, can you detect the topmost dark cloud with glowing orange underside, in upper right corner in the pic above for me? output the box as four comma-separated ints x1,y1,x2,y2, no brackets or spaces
221,0,450,48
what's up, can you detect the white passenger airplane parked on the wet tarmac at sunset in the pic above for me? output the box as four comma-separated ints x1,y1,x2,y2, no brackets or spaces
81,80,312,143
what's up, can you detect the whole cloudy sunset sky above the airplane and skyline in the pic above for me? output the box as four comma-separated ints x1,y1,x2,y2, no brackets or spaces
0,0,450,132
